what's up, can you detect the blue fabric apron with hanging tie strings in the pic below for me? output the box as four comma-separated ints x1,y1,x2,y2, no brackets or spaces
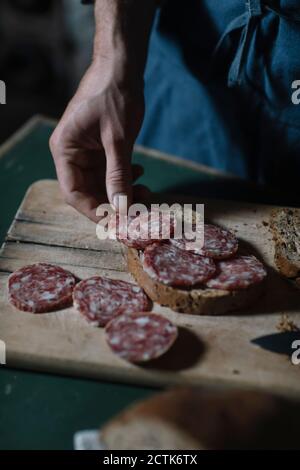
138,0,300,188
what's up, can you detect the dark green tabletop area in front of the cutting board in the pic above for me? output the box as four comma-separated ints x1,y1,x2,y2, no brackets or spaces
0,368,153,450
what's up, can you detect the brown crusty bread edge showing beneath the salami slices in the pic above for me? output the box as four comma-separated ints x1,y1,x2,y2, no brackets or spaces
127,248,264,315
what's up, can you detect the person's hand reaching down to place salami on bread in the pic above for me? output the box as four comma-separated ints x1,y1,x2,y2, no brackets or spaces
50,59,144,222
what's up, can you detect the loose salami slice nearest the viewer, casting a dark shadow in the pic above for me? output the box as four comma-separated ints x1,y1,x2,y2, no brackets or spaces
105,313,178,363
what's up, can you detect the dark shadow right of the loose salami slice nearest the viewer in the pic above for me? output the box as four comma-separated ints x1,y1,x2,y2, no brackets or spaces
143,327,206,372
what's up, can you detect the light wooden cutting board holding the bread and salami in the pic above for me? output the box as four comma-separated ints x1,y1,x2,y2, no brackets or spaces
0,180,300,396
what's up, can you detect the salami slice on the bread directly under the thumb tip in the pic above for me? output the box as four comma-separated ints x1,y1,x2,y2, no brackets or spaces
109,211,175,250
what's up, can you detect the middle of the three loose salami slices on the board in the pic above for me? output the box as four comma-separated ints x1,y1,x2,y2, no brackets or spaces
73,276,150,326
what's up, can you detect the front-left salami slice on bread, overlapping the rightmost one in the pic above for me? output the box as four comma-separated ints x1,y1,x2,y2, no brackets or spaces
142,243,216,287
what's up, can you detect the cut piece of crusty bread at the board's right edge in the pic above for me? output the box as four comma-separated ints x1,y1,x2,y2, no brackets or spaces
270,208,300,278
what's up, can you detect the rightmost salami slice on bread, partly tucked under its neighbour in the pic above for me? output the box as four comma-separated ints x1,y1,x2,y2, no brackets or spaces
206,256,267,290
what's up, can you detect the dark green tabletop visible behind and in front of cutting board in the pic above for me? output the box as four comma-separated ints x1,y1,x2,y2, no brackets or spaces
0,122,211,449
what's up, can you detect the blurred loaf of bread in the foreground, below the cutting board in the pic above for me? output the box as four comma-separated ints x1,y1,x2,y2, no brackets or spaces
101,388,300,450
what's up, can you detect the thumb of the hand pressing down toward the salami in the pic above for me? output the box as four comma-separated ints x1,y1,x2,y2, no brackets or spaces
105,143,132,212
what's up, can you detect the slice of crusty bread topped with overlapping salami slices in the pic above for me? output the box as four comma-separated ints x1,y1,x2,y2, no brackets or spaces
109,212,267,315
